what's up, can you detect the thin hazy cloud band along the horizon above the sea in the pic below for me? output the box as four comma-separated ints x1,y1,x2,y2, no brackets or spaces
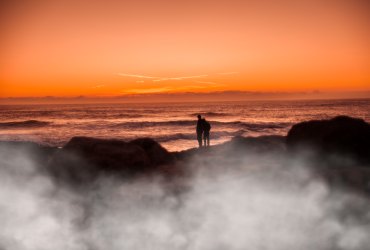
0,90,370,105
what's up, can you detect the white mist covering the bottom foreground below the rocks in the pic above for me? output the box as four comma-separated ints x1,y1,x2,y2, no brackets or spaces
0,143,370,250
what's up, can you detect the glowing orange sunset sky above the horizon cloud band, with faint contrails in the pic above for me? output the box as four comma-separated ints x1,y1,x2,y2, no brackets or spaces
0,0,370,97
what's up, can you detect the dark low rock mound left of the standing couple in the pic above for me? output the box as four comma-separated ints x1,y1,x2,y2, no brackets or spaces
48,137,174,184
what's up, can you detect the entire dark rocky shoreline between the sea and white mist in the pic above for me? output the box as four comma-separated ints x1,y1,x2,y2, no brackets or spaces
0,117,370,192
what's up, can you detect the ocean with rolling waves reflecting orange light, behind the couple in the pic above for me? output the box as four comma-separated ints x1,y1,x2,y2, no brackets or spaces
0,99,370,151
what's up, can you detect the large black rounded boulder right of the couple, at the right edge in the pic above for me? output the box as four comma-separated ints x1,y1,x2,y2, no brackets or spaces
287,116,370,162
